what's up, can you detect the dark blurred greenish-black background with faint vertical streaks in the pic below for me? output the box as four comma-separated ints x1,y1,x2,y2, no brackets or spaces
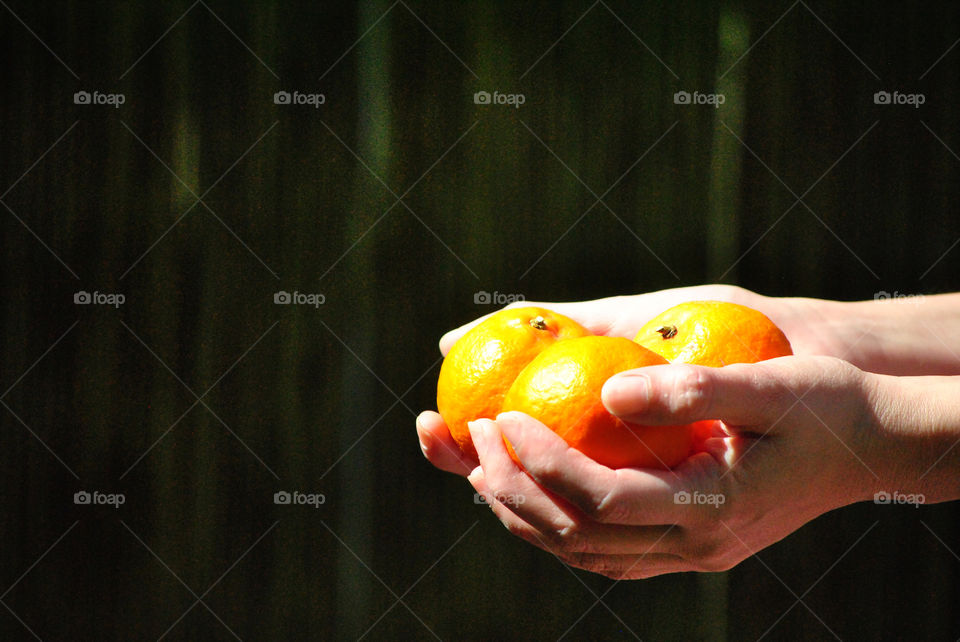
0,0,960,640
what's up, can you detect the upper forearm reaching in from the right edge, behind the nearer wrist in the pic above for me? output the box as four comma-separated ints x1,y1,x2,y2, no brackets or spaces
785,293,960,375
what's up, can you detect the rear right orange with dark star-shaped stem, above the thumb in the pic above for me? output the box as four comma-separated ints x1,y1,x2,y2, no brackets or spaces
634,301,793,367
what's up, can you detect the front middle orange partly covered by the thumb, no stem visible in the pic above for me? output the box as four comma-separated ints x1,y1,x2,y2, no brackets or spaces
503,336,693,468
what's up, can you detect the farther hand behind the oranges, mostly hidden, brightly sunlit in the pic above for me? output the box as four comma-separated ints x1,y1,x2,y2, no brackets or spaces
417,285,845,476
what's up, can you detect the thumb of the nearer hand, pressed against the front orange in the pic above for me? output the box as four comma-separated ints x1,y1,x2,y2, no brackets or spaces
601,364,798,428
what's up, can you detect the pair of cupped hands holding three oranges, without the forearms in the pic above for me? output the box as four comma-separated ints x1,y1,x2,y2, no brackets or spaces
417,285,896,579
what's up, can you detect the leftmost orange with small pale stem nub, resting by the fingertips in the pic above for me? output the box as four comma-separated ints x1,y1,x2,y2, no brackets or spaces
437,307,590,458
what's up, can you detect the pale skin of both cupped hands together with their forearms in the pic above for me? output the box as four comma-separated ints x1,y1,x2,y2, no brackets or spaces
417,285,960,579
